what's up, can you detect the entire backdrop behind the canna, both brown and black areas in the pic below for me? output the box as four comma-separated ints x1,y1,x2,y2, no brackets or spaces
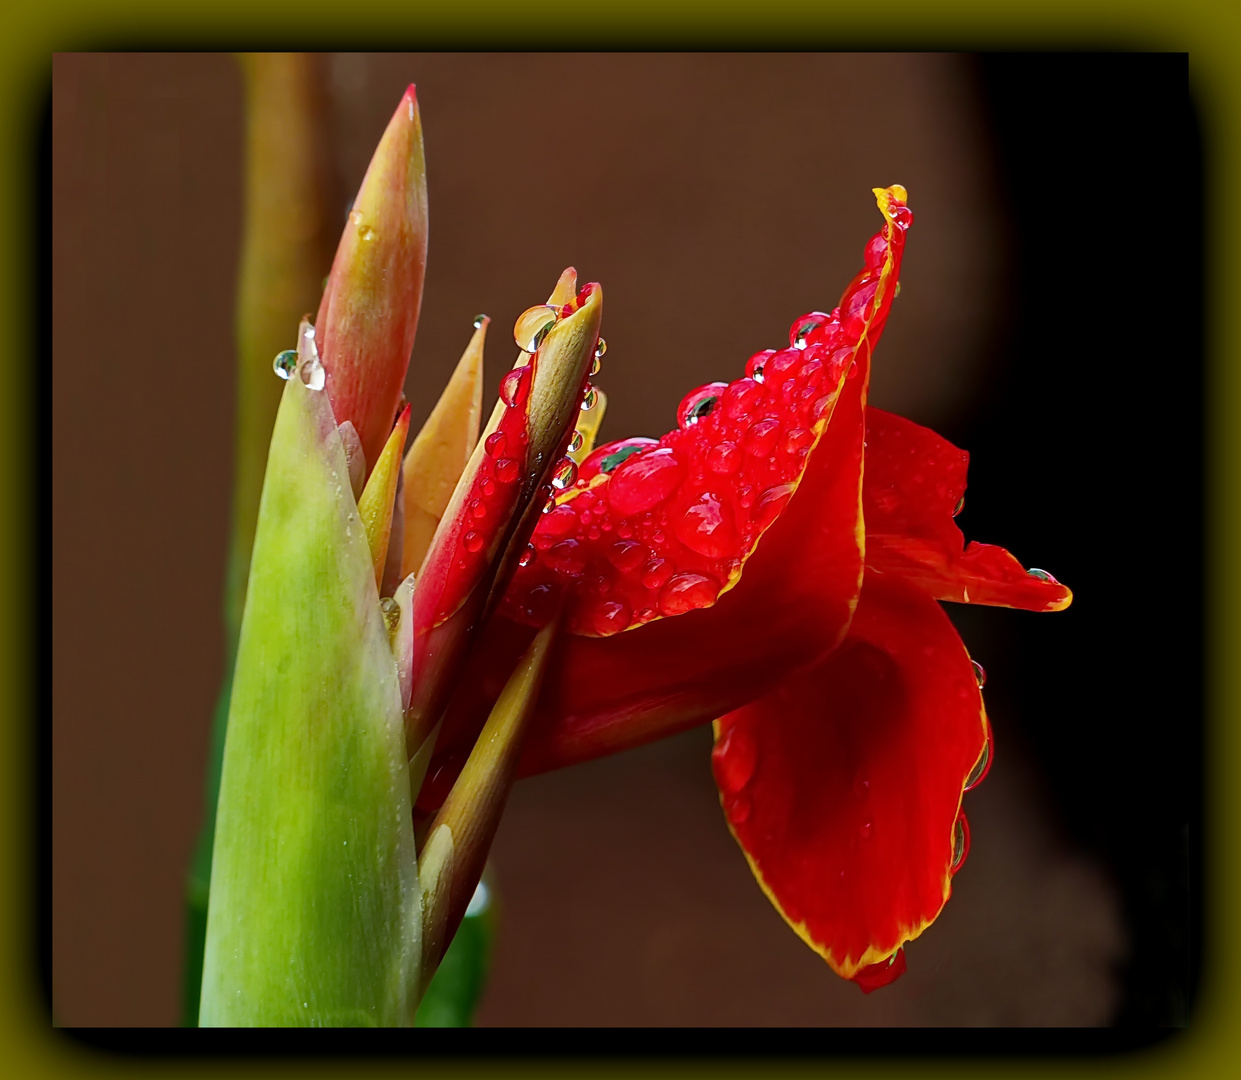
51,55,1201,1027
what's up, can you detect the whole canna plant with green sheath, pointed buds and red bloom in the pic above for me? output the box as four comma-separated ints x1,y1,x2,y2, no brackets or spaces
200,73,1071,1025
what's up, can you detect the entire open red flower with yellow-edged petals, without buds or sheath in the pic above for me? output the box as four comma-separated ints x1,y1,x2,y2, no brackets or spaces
418,186,1071,992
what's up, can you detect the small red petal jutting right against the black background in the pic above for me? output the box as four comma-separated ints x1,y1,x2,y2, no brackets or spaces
862,408,1073,611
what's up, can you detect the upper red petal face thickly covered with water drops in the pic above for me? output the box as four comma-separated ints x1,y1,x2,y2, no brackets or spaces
493,235,913,636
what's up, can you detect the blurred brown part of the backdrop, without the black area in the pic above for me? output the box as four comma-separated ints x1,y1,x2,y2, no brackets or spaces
51,55,1181,1025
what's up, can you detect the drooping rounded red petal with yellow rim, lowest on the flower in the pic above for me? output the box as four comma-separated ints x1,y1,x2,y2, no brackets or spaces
711,578,987,982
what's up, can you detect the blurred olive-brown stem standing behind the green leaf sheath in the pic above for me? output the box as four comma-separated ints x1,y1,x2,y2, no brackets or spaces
182,53,338,1025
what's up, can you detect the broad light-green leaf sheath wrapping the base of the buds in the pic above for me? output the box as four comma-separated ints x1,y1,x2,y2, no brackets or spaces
200,375,421,1027
